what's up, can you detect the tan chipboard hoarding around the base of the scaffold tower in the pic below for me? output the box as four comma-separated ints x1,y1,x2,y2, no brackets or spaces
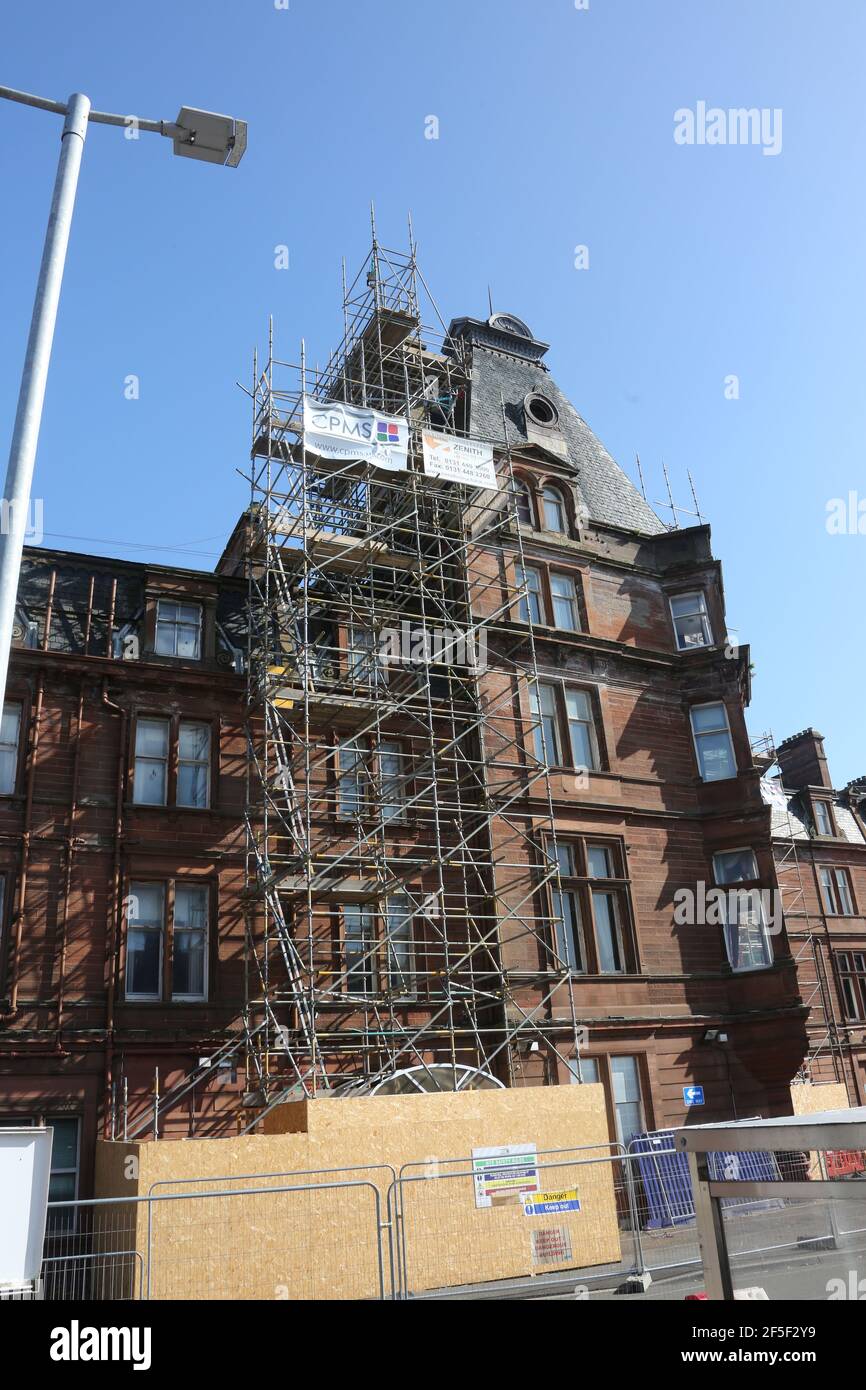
97,1086,620,1300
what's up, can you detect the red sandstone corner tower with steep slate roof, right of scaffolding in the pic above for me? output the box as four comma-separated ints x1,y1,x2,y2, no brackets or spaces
455,318,805,1141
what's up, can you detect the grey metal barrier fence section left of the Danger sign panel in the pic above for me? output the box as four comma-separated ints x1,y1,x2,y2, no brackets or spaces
29,1169,393,1301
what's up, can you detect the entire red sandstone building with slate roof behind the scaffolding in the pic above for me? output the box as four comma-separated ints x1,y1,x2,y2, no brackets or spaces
0,284,811,1197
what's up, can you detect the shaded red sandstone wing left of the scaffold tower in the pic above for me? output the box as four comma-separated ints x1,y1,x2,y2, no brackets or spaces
0,549,246,1198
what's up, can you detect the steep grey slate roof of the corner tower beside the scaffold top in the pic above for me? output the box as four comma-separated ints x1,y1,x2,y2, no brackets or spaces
452,320,667,535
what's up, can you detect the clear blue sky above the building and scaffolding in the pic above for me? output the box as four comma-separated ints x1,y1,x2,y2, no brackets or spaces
0,0,866,784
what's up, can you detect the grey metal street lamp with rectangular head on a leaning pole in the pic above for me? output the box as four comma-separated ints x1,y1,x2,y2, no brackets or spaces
0,86,246,712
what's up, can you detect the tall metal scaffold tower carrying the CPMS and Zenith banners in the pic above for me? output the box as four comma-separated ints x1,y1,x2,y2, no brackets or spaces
240,225,580,1123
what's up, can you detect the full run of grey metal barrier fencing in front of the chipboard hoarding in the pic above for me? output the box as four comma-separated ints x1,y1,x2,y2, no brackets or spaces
13,1131,866,1300
